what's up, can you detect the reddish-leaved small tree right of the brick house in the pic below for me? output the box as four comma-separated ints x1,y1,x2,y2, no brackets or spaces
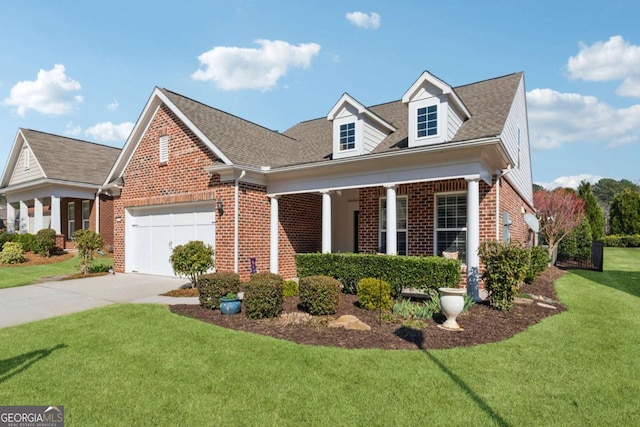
533,188,584,257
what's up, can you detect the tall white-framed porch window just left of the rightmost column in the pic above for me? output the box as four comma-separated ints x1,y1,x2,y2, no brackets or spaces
436,194,467,263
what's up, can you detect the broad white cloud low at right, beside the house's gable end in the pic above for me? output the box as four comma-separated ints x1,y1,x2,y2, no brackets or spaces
527,89,640,149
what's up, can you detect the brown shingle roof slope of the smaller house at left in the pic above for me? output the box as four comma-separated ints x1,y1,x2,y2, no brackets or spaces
20,129,120,185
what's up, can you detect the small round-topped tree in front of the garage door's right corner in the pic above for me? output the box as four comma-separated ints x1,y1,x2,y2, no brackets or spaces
169,240,215,288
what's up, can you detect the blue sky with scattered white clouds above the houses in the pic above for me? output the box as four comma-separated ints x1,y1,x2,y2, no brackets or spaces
0,0,640,187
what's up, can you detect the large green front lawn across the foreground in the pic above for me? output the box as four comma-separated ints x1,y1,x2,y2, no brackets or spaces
0,249,640,426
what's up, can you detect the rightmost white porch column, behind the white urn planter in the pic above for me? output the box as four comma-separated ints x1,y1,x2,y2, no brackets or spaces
467,178,480,301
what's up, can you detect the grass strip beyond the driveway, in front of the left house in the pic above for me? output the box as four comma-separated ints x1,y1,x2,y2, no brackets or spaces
0,257,113,289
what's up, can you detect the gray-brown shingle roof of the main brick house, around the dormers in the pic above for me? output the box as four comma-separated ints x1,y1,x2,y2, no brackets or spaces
160,72,522,167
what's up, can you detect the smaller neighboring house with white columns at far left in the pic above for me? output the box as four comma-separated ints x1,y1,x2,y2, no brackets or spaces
0,129,120,248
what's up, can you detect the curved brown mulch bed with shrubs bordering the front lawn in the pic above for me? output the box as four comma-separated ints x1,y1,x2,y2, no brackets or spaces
170,267,565,350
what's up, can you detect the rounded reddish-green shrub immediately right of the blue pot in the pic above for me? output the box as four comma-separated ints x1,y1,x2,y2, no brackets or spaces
244,272,283,319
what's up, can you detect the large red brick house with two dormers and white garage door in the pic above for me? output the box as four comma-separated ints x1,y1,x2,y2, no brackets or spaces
105,72,533,285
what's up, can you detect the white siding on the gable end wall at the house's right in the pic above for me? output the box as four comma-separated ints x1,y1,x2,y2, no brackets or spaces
500,78,533,205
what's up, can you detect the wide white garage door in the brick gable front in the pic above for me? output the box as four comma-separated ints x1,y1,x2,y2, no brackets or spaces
125,202,216,276
